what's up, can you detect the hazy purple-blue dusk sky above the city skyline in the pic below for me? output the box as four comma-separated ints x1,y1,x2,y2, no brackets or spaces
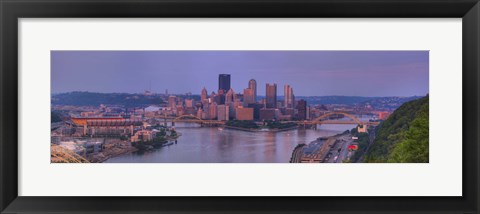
51,51,429,97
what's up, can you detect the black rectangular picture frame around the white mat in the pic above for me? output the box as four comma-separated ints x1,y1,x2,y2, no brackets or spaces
0,0,480,213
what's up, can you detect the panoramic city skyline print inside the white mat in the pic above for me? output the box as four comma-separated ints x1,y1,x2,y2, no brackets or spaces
50,51,429,164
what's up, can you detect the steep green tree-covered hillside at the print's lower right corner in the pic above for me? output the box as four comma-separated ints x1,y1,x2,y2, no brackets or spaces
365,95,429,163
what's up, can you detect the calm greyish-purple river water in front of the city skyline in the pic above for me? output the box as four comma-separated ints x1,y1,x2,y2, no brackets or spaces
105,118,372,163
